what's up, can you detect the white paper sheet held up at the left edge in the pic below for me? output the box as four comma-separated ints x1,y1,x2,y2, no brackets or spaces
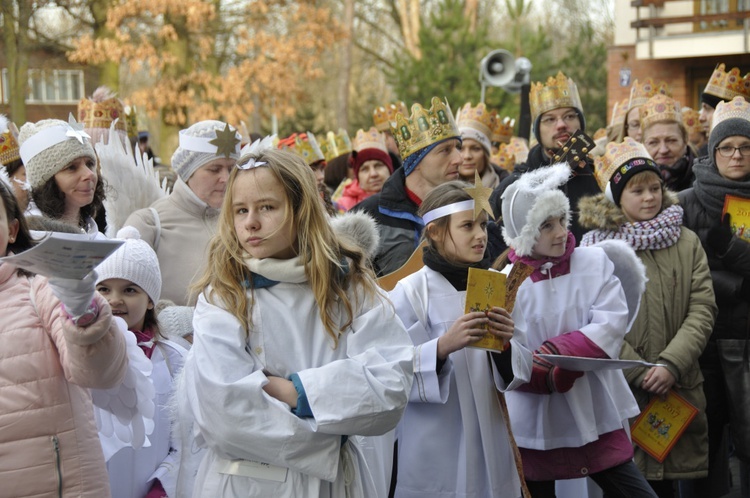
0,232,124,280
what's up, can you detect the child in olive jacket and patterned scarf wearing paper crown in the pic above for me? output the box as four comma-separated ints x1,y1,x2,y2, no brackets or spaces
578,137,716,497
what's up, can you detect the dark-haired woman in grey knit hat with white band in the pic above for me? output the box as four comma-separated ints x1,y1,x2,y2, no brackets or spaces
18,117,104,235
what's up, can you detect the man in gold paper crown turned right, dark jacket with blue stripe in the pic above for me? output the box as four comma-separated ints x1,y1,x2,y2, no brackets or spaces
354,97,461,275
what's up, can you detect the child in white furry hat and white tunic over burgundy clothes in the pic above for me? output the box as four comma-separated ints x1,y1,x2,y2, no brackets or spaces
502,164,656,498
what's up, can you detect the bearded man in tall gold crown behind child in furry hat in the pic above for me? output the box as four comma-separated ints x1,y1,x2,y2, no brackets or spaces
490,72,600,249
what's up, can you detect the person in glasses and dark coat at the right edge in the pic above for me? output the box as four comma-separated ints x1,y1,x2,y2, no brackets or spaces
679,96,750,496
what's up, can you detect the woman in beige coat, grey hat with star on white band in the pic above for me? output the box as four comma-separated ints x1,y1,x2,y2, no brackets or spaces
125,120,240,305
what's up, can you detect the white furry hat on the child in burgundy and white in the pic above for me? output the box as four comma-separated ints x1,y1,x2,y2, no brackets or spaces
502,163,570,256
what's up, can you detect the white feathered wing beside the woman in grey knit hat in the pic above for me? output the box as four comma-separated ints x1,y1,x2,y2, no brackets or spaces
94,122,169,238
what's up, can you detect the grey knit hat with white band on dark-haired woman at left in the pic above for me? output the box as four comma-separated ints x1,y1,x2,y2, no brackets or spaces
18,117,96,188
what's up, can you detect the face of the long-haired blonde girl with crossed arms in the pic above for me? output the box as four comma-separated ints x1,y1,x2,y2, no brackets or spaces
231,167,297,259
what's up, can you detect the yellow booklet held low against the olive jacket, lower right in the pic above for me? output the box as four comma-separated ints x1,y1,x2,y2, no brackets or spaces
630,390,698,463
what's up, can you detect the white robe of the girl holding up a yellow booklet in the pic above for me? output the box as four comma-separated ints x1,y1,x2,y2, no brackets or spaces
390,267,531,498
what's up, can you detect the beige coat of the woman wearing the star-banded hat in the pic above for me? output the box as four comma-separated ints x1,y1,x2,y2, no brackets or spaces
125,179,219,306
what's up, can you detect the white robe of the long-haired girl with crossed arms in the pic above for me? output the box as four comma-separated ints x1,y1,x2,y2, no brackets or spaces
184,260,414,498
